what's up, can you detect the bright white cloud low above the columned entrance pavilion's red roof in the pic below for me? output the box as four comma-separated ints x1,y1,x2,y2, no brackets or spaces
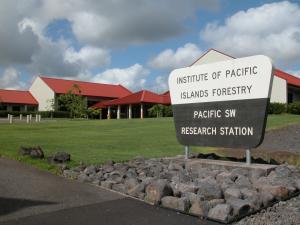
92,64,150,90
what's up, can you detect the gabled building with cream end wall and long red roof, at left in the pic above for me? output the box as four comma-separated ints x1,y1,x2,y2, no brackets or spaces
29,76,132,111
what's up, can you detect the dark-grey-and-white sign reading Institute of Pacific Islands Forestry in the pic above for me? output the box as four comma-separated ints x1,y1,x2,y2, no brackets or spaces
169,55,273,160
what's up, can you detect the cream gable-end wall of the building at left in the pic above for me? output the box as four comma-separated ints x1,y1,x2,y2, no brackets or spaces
29,77,55,111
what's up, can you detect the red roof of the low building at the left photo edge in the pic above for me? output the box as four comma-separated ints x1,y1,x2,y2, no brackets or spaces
0,89,39,105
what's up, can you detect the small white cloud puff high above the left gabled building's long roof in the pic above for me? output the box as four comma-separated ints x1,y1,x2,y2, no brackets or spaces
64,46,110,69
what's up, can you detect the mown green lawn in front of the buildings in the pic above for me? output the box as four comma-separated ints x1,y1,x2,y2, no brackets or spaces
0,115,300,169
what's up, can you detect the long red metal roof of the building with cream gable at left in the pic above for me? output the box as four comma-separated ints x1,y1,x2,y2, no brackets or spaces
40,77,132,98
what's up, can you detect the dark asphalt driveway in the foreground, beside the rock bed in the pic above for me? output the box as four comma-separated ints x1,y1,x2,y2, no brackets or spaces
0,158,217,225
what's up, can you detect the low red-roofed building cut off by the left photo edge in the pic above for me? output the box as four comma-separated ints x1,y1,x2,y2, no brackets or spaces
0,89,39,111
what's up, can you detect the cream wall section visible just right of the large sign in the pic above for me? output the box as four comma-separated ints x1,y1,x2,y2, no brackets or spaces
270,76,287,103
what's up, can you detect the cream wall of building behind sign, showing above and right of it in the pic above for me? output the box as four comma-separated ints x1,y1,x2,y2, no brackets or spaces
192,50,287,103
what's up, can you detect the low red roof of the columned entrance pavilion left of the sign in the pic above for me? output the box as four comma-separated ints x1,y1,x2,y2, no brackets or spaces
92,90,171,108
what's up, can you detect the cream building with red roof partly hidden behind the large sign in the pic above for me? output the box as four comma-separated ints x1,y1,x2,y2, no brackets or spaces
190,49,300,103
